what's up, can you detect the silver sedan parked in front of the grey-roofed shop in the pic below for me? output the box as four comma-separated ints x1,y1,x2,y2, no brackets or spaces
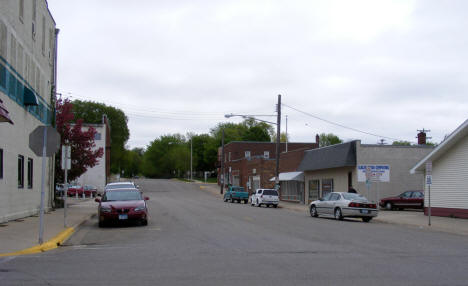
309,192,378,222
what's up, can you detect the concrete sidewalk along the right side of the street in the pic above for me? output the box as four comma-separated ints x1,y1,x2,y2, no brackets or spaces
198,183,468,236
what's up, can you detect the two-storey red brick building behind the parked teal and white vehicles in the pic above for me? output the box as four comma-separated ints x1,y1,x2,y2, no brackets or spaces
218,141,318,196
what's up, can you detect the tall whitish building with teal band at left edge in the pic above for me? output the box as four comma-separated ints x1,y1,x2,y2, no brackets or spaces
0,0,58,222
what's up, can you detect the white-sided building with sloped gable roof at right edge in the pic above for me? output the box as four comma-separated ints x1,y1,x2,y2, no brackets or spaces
411,120,468,218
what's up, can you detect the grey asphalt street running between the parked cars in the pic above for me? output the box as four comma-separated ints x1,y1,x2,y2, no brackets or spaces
0,180,468,286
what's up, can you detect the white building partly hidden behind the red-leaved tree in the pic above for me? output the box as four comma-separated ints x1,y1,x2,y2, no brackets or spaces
76,116,110,192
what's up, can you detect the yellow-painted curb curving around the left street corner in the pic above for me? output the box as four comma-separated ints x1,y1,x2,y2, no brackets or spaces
0,214,96,257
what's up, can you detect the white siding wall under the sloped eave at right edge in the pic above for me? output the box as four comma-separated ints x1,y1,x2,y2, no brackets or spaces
425,136,468,209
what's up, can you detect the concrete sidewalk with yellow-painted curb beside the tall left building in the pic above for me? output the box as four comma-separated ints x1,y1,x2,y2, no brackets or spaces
0,198,97,256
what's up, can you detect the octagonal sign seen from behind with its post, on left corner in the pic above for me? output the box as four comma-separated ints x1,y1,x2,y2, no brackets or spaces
29,126,60,244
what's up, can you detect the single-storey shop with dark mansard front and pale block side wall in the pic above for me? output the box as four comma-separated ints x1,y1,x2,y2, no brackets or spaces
298,140,433,203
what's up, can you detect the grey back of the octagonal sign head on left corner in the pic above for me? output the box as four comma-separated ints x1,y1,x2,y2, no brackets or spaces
29,126,60,157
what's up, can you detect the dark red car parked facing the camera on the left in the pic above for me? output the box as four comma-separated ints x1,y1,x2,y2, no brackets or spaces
95,188,149,227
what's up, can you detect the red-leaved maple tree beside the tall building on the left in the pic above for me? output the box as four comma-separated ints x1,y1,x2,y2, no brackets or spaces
55,98,104,182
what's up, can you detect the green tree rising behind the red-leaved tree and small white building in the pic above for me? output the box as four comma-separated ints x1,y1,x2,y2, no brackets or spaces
73,100,130,173
